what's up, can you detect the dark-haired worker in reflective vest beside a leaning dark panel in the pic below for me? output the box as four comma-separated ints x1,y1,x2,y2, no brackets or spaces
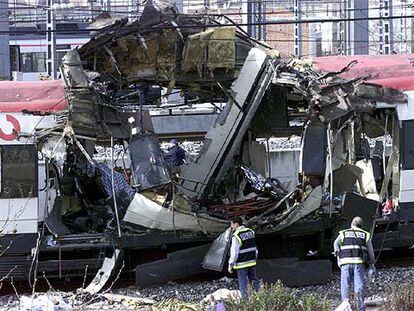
229,217,260,298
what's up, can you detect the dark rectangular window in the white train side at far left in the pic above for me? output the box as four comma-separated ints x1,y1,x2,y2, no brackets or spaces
0,145,38,199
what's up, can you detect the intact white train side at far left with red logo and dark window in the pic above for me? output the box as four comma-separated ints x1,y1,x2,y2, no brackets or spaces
0,113,54,236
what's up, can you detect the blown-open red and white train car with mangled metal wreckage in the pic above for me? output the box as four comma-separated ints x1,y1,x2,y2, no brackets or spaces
0,1,413,292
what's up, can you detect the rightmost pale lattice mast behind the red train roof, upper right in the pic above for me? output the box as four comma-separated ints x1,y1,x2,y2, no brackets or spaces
378,0,394,54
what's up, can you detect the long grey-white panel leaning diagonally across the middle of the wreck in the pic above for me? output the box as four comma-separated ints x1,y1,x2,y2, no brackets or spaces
181,48,273,197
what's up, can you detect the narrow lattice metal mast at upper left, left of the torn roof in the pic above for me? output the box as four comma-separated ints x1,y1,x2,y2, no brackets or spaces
46,0,57,80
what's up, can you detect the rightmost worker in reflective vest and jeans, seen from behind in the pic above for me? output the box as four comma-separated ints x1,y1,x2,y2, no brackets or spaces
334,217,375,310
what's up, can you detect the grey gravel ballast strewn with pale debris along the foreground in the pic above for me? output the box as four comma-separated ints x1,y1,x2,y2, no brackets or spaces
0,267,414,311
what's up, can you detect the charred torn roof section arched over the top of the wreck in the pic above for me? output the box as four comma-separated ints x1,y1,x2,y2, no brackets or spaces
79,5,254,96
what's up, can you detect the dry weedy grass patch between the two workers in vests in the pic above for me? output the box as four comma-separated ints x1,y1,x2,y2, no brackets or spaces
224,281,330,311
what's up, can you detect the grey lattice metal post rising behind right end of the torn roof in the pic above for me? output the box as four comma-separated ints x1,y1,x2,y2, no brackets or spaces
247,0,266,41
